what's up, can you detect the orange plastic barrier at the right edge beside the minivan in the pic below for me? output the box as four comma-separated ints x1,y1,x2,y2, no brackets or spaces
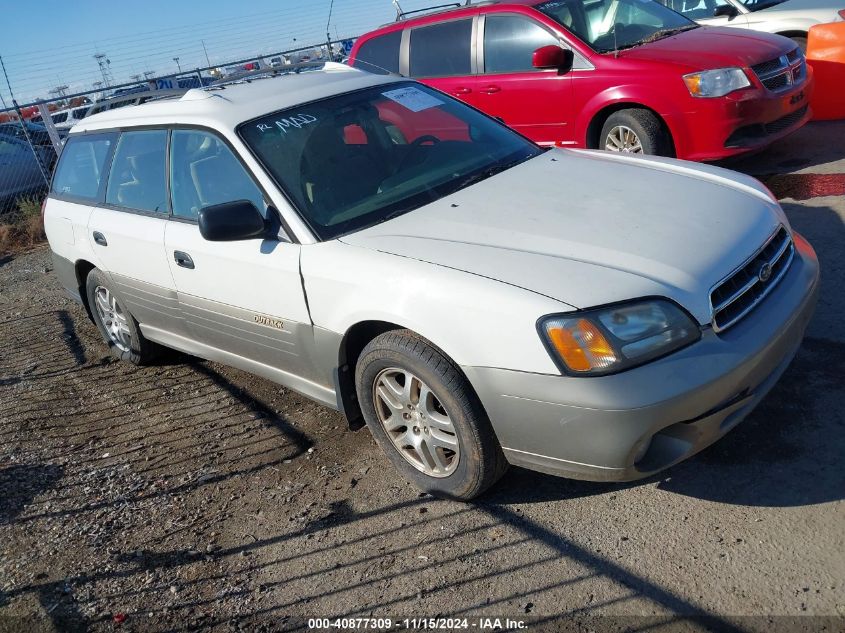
807,22,845,120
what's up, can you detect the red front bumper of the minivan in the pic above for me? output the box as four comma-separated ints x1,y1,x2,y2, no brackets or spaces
666,66,815,161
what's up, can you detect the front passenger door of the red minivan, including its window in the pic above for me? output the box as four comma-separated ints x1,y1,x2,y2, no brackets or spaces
470,12,574,145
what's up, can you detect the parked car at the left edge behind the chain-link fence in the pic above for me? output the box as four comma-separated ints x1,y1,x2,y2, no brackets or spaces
0,134,49,213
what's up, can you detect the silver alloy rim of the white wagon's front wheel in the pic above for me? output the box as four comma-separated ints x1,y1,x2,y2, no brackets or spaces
373,367,461,477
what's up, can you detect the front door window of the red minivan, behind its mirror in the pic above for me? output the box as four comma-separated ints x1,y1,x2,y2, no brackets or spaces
484,15,559,73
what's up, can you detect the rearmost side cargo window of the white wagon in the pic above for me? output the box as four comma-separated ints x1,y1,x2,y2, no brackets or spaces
52,134,117,200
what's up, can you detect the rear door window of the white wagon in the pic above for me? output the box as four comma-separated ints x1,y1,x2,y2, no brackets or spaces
106,130,168,214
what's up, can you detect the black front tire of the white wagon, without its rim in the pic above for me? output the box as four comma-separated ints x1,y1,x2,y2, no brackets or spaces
355,330,508,501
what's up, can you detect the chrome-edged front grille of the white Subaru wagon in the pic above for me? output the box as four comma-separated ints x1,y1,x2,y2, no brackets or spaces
710,226,795,332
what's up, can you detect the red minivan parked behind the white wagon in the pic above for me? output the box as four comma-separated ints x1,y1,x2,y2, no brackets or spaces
349,0,813,161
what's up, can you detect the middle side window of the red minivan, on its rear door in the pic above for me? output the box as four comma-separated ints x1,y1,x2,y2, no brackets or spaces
410,18,472,77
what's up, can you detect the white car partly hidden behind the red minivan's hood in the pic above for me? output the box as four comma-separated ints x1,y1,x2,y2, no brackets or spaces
660,0,845,51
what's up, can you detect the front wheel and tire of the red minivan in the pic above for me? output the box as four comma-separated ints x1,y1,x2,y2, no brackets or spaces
599,108,672,156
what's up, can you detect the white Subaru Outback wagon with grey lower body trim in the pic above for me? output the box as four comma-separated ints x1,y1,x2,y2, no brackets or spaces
45,64,819,499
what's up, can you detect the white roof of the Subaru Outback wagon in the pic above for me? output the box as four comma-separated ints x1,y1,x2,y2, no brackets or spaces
72,63,407,134
